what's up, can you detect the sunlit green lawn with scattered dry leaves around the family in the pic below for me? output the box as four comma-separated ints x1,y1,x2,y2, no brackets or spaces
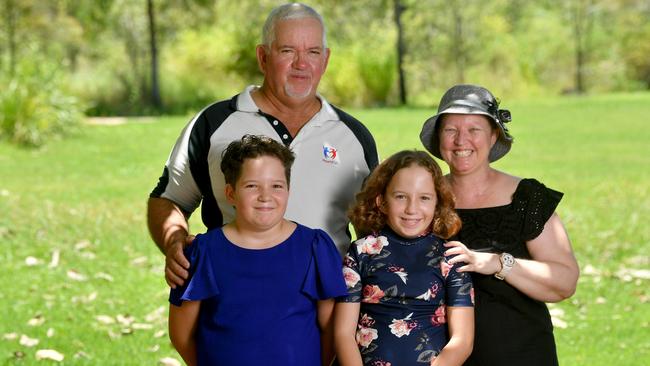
0,94,650,366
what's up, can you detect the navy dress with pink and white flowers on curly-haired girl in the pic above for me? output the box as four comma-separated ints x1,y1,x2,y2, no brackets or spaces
338,228,474,366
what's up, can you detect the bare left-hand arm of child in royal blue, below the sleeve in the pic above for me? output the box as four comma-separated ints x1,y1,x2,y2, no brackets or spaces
169,301,201,366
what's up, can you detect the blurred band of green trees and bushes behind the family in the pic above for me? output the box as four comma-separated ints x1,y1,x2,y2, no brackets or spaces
0,0,650,145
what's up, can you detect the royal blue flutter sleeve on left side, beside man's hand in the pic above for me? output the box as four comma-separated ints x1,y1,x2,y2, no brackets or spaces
169,234,219,306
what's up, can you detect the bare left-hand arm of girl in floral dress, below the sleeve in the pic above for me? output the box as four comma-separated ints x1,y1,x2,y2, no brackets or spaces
334,302,363,366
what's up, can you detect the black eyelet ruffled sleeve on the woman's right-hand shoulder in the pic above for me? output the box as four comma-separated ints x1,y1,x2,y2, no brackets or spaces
512,179,564,241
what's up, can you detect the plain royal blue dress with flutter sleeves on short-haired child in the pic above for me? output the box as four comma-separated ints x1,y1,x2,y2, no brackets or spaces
169,225,347,366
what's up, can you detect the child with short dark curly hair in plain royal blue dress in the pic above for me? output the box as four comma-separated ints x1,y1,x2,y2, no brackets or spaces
169,135,347,366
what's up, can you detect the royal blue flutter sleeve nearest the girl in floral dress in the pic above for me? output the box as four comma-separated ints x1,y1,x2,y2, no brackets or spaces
302,229,347,300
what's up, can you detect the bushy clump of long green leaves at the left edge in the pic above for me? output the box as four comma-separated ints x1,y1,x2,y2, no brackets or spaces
0,59,83,146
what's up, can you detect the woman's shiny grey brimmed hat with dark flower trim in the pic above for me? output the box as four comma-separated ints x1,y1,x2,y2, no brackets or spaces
420,84,513,162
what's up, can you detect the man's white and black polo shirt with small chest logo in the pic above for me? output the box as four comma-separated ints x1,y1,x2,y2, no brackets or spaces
150,86,378,255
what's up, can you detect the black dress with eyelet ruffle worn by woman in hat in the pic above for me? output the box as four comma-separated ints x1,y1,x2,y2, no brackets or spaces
452,179,563,366
